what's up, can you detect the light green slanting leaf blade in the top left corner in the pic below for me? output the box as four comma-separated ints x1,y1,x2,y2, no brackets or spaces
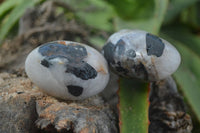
0,0,39,41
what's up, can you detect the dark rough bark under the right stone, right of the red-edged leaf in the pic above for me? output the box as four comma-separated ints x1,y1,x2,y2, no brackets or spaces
149,77,192,133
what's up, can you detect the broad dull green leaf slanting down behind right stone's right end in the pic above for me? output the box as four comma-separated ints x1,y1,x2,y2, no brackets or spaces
164,35,200,121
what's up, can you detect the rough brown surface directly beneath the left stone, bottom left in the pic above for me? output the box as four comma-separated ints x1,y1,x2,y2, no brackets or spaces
0,73,118,133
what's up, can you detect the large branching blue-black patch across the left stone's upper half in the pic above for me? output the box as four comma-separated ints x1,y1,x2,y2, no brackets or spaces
39,42,97,80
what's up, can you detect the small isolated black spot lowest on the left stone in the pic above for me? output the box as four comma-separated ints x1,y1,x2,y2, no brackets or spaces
67,85,83,97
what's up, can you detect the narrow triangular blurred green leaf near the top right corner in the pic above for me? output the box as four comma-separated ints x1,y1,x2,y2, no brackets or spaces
164,0,199,22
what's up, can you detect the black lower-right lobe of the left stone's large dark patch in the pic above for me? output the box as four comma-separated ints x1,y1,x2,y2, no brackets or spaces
65,62,97,80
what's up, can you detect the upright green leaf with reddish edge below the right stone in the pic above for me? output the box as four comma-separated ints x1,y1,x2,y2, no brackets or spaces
119,78,149,133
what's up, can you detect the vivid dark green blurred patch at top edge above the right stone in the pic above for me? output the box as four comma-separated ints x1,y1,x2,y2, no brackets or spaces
107,0,155,20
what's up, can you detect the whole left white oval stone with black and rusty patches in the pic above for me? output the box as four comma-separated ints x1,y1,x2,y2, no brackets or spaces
25,40,109,100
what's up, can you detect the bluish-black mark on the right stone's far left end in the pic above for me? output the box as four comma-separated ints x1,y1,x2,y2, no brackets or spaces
103,42,115,64
